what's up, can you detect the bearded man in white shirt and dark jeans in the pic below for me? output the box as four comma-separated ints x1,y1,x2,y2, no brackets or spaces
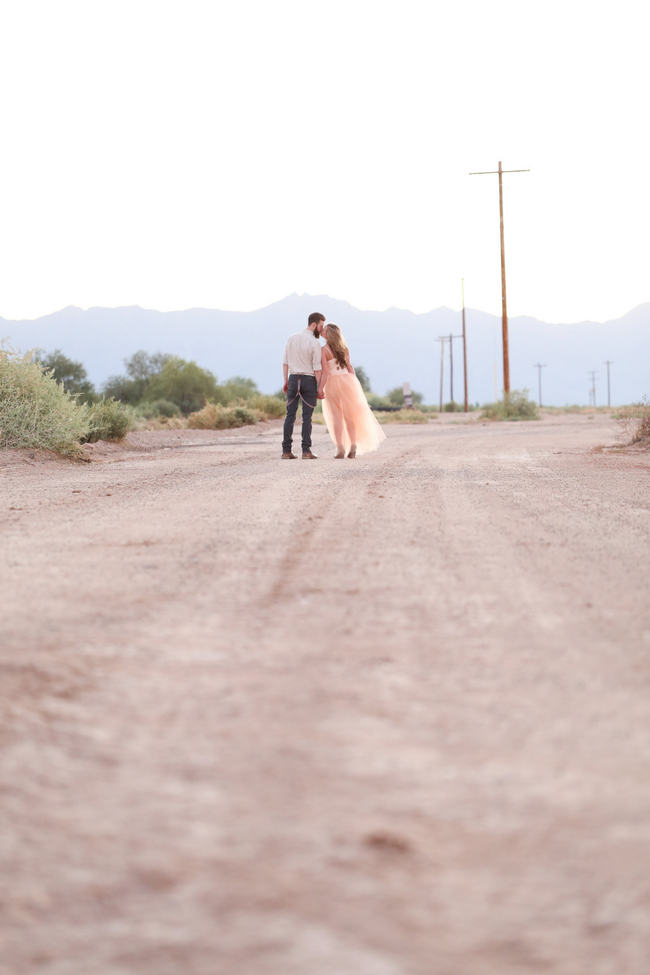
282,311,325,460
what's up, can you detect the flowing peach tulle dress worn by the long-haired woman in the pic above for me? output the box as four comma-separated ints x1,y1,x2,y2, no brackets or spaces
323,358,386,454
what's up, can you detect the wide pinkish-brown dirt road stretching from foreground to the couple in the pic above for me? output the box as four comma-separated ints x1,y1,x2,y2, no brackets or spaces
0,416,650,975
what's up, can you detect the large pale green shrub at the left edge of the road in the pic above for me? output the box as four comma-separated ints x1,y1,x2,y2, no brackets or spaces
0,348,89,454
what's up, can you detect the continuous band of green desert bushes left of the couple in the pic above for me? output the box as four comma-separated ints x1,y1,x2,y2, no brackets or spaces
0,346,285,456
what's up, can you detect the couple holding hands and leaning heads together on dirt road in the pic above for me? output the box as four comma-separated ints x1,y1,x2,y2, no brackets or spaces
282,312,386,460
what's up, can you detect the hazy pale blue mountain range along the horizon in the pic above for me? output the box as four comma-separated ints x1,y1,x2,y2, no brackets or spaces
0,294,650,406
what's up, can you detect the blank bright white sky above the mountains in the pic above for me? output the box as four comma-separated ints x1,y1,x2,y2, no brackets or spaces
0,0,650,321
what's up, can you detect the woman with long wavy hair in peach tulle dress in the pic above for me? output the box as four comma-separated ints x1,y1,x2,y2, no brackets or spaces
318,324,386,460
